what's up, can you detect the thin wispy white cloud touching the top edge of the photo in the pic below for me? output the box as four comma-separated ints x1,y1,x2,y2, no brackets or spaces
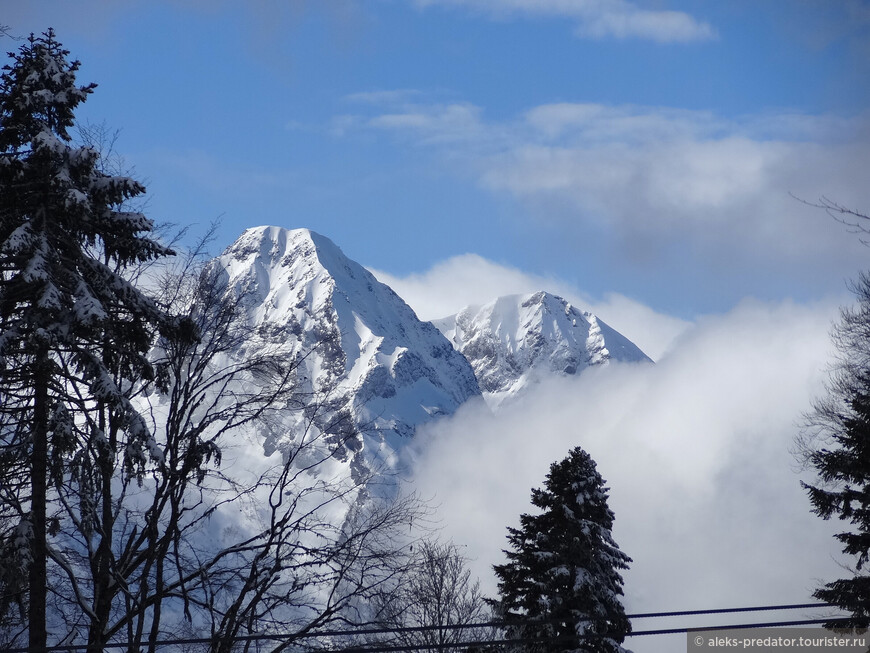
416,0,716,43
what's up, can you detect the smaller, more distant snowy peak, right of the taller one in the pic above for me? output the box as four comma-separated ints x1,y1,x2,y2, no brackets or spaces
434,291,650,403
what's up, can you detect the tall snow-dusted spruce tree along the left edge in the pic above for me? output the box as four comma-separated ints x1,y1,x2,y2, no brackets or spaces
0,29,169,650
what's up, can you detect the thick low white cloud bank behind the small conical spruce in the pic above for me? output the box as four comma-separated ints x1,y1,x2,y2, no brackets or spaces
408,301,842,651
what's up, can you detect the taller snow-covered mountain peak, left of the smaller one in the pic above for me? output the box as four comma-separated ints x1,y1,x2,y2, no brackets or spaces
218,226,480,460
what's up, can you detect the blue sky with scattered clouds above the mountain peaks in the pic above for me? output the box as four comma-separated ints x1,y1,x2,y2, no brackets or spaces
3,0,870,319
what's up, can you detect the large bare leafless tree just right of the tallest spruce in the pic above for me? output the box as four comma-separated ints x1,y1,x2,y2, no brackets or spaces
29,247,419,652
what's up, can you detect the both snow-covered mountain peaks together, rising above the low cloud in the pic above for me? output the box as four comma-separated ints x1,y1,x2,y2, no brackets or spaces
213,226,649,478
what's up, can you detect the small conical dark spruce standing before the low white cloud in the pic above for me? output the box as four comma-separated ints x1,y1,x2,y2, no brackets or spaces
494,447,631,653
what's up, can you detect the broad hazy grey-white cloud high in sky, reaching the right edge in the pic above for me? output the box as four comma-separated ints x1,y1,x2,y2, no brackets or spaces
488,104,870,254
